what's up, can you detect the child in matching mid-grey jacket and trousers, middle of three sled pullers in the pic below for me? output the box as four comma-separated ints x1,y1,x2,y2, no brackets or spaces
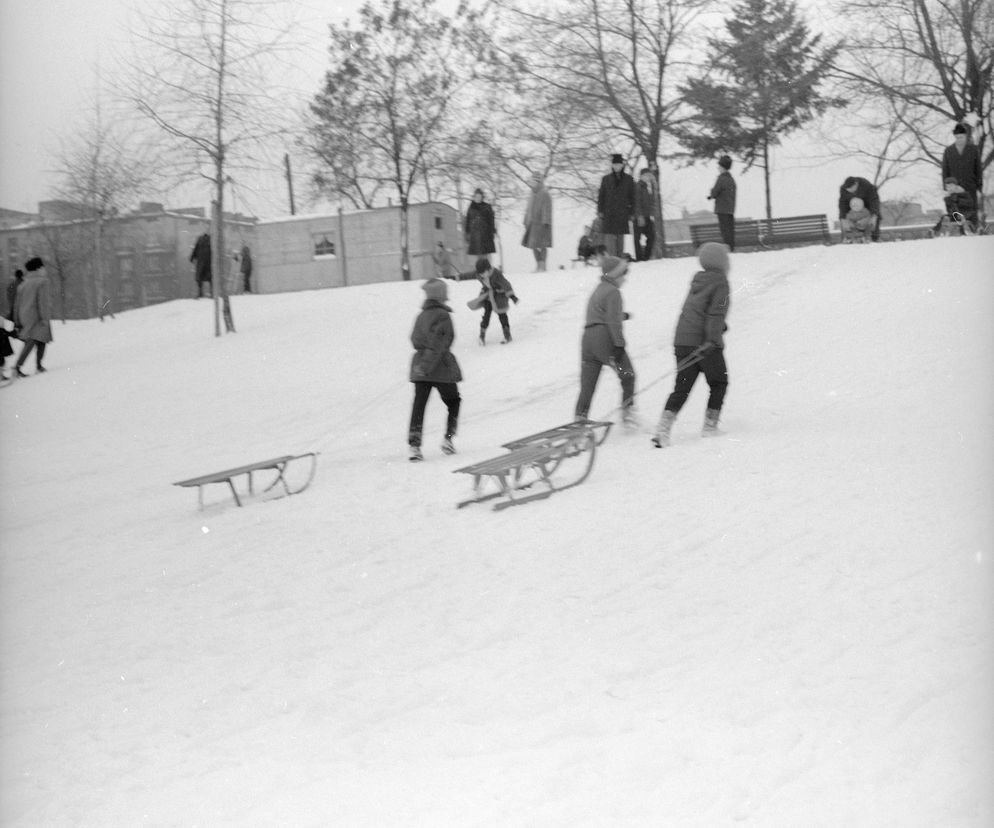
574,256,637,428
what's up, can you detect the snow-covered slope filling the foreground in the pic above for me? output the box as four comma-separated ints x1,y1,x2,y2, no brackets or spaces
0,238,994,828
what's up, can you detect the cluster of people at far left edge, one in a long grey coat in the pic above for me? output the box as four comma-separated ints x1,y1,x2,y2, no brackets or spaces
0,256,52,379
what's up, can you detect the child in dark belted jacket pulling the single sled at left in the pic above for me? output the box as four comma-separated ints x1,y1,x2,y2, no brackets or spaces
407,279,462,460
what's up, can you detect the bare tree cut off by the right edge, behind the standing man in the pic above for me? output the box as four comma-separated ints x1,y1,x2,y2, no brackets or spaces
835,0,994,188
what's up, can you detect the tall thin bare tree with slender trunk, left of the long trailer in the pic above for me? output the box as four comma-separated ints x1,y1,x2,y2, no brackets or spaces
126,0,293,336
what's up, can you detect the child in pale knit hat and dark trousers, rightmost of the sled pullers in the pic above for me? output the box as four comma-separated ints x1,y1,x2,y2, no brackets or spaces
652,242,731,448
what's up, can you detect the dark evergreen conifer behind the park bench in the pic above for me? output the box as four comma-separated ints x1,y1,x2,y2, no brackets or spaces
677,0,844,218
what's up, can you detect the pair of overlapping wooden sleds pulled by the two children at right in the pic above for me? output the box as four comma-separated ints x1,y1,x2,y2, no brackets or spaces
455,420,612,510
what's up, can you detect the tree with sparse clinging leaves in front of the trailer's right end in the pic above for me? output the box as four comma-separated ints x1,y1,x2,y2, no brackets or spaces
308,0,478,279
